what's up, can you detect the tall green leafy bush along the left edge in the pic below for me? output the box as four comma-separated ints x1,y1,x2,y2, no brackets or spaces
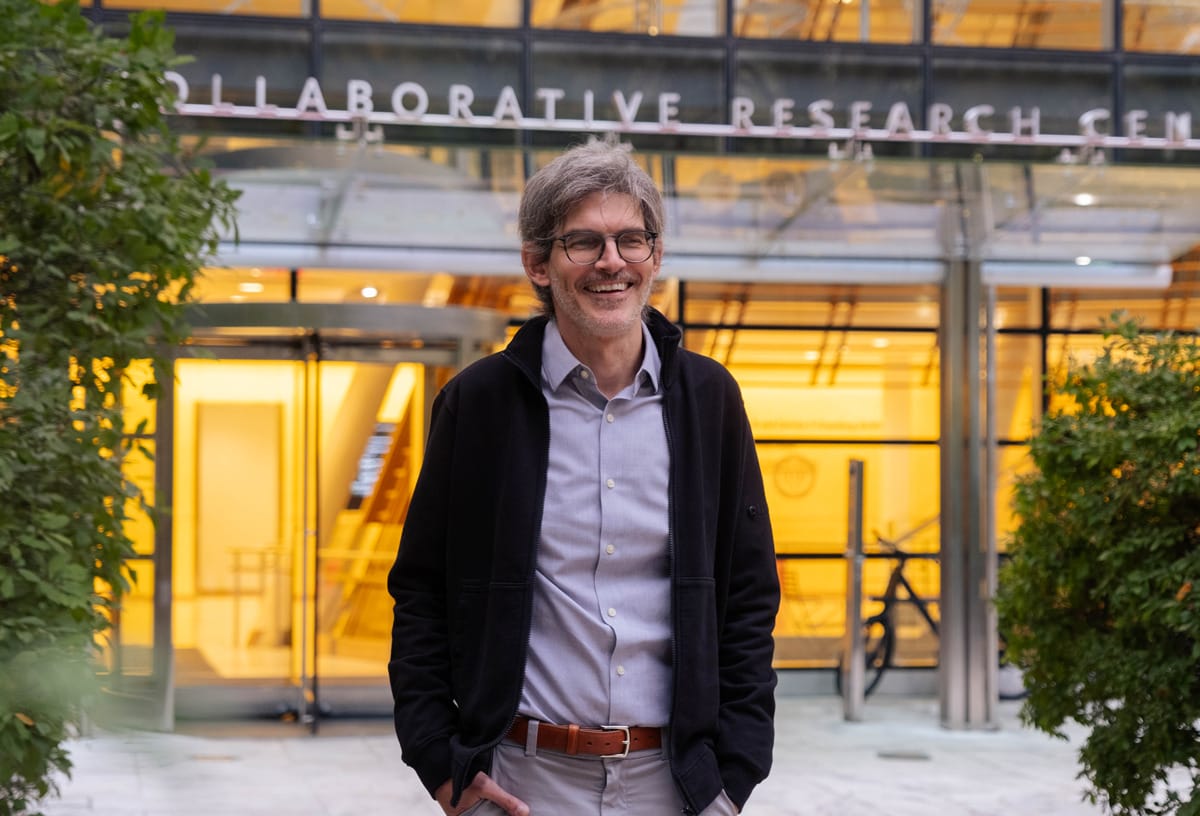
0,0,235,816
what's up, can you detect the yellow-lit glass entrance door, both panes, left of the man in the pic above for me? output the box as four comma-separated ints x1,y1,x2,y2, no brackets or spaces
172,343,434,721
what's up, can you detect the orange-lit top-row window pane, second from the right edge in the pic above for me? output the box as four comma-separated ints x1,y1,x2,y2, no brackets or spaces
930,0,1112,50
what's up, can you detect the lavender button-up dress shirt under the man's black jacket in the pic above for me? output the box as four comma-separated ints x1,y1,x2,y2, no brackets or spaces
520,322,671,726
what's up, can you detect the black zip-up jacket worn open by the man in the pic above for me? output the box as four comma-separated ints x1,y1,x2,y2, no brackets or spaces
388,310,779,812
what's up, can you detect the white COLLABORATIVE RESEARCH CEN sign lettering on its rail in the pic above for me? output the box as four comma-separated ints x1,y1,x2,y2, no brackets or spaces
166,71,1200,150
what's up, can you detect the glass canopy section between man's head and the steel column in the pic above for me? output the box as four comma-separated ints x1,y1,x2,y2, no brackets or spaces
664,156,954,259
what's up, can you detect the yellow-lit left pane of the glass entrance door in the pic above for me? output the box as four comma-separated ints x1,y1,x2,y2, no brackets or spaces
170,359,306,688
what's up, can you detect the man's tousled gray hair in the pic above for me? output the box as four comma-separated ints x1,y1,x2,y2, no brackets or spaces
517,139,666,317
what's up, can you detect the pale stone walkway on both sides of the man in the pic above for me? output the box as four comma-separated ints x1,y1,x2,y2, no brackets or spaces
44,695,1103,816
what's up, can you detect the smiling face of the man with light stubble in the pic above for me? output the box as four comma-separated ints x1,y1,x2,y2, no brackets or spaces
522,192,662,350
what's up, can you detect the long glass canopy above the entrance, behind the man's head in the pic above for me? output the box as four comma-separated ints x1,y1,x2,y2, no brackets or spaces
208,139,1200,287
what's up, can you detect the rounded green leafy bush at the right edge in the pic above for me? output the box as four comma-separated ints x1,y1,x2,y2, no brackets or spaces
997,314,1200,816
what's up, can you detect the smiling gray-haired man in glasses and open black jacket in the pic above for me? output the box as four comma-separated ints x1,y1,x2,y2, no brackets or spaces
388,136,779,816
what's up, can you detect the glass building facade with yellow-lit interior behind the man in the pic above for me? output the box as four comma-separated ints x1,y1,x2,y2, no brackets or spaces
90,0,1200,726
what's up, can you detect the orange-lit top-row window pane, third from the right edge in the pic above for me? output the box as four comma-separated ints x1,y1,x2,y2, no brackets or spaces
733,0,920,42
